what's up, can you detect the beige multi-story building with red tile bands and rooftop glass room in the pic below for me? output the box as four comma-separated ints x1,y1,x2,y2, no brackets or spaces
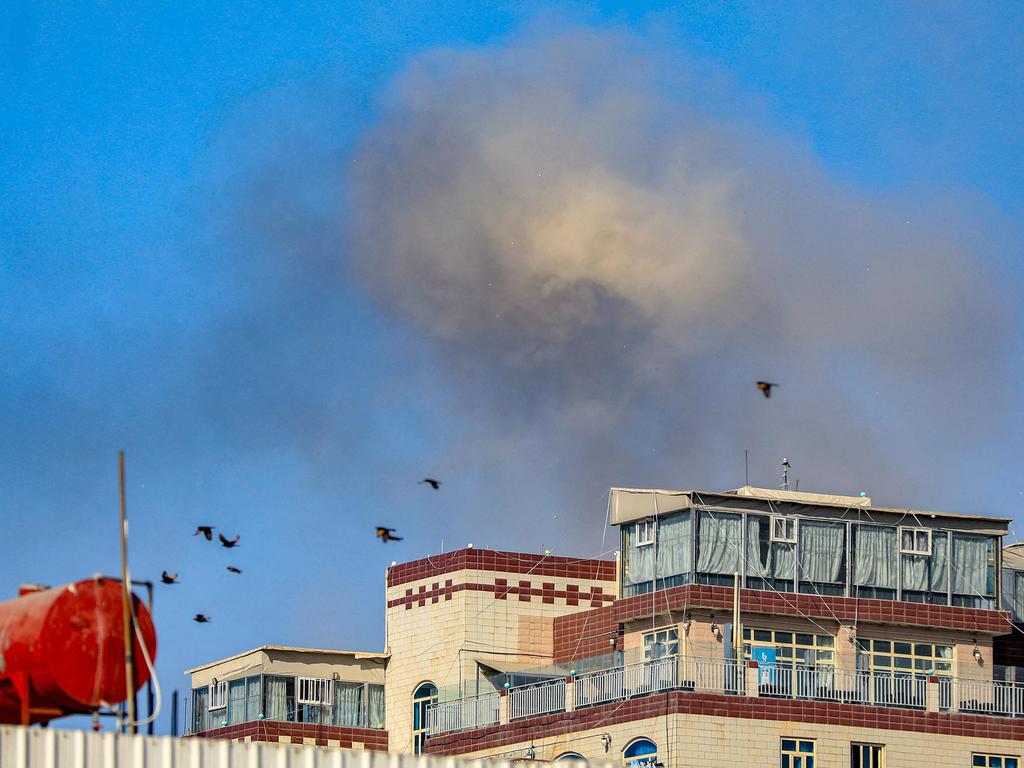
184,487,1024,768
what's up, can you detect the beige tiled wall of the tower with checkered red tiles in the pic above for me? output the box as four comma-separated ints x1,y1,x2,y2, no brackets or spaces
385,569,614,753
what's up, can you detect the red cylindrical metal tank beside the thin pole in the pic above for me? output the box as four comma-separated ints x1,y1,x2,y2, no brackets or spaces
0,577,157,723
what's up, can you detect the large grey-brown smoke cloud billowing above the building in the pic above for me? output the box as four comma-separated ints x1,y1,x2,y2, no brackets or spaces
349,29,1007,528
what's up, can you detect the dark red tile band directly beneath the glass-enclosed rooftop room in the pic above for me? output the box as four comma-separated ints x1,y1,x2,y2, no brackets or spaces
554,584,1011,662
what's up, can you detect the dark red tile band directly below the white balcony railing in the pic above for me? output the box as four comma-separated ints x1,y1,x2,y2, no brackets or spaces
427,691,1024,755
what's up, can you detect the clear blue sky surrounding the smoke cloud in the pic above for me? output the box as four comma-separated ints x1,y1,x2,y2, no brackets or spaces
0,0,1024,727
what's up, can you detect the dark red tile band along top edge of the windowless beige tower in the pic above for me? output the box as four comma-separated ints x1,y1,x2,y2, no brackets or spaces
387,548,615,587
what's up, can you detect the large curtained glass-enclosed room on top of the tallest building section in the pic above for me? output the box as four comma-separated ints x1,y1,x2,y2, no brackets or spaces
609,486,1010,608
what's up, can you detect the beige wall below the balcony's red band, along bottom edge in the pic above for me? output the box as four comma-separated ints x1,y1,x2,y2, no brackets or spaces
460,715,1024,768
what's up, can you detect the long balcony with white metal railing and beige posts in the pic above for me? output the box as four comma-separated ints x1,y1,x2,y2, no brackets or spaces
427,656,1024,736
